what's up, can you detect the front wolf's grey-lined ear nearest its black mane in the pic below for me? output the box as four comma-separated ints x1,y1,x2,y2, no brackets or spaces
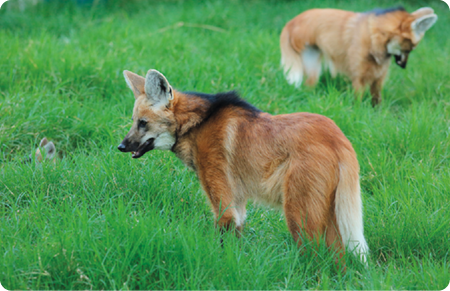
145,70,173,107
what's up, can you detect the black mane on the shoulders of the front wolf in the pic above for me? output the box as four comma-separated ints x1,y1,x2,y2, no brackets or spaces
184,91,261,119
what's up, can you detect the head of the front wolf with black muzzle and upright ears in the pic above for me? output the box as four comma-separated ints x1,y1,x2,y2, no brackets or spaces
118,70,176,158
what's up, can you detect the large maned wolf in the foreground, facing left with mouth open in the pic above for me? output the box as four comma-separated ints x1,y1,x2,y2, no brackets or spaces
118,70,368,261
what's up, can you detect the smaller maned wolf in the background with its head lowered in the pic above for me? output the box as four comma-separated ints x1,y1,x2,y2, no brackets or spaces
280,7,437,106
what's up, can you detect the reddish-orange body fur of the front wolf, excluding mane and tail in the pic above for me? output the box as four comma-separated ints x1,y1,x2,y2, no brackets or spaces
172,92,359,253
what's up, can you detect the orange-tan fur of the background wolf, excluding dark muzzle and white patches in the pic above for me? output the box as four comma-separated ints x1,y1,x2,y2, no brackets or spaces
280,9,436,105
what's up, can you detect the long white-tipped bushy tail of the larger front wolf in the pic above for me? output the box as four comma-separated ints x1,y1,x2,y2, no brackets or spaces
335,159,369,263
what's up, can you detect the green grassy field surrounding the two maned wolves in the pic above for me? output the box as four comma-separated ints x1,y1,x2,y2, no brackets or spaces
0,0,450,290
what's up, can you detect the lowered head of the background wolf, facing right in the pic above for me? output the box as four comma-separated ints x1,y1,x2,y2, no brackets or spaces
370,7,437,68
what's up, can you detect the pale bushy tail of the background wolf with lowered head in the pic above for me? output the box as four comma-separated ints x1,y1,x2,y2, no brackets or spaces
280,27,303,87
